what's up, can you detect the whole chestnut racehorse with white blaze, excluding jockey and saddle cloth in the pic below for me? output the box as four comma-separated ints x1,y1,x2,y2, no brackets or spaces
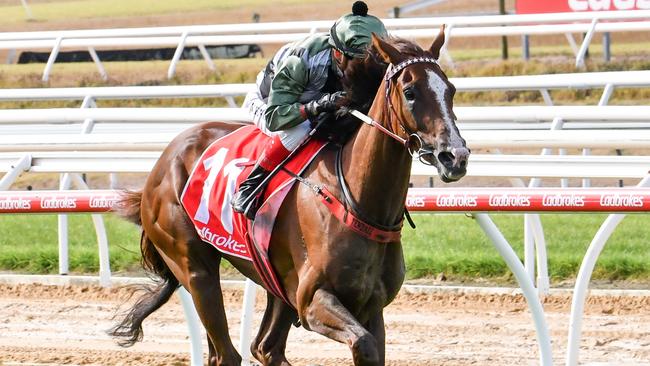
112,28,469,365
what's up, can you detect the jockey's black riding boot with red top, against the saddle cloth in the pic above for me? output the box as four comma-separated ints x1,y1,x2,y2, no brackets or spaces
231,135,290,220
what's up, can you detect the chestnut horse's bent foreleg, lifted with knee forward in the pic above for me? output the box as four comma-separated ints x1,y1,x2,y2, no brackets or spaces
302,289,383,366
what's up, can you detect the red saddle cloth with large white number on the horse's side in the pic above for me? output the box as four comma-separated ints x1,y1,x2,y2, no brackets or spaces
181,126,326,301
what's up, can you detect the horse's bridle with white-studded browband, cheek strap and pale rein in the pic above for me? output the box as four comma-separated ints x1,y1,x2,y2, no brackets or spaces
350,57,438,165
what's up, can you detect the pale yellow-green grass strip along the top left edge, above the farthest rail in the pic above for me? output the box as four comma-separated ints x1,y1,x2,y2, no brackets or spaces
0,0,313,24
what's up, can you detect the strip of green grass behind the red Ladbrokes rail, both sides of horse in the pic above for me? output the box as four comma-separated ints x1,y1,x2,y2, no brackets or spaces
0,214,650,283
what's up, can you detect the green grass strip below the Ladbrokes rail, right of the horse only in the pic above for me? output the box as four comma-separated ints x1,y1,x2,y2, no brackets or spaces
403,214,650,281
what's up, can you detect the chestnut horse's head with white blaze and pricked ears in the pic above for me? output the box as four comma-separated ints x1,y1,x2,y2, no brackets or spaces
372,26,470,182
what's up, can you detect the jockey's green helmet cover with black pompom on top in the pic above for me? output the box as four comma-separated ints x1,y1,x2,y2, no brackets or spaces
329,1,388,57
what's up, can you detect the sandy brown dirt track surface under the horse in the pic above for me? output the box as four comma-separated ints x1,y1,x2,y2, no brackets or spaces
0,285,650,366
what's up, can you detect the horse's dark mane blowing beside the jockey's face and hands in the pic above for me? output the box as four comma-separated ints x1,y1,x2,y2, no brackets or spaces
318,37,426,143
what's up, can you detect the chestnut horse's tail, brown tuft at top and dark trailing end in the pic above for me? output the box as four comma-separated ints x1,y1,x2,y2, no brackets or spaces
108,191,179,347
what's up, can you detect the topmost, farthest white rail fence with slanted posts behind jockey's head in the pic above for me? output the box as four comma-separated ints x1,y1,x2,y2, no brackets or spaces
0,10,650,80
